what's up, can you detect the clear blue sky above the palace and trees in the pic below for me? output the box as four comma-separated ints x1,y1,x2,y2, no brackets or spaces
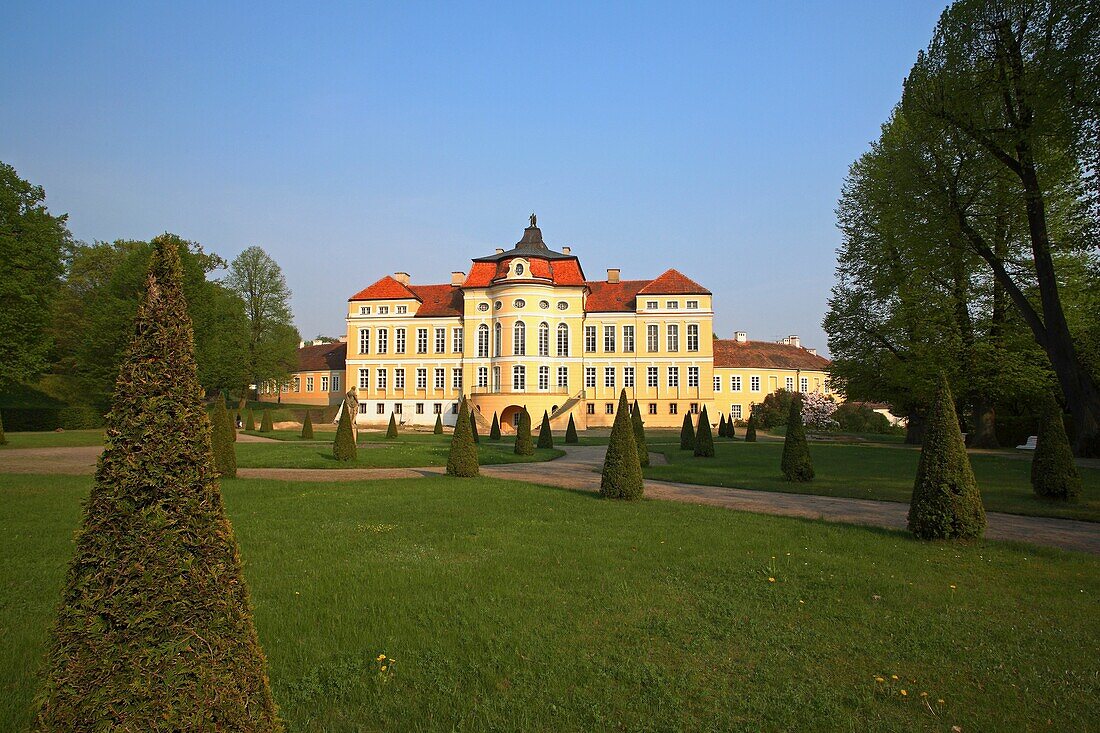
0,0,944,348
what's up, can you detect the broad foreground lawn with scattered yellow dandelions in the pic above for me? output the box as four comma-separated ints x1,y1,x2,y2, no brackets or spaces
0,475,1100,732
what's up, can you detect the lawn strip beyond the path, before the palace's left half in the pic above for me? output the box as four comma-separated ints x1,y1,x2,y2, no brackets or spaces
237,434,563,469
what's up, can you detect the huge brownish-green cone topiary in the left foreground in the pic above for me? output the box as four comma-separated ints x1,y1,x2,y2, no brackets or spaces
33,238,282,732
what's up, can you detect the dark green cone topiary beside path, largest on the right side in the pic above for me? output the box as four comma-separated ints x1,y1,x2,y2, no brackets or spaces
906,375,986,539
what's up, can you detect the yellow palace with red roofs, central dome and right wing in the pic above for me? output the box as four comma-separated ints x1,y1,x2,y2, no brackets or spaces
338,220,829,429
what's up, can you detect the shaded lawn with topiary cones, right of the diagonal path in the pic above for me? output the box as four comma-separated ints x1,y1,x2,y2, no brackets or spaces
645,440,1100,522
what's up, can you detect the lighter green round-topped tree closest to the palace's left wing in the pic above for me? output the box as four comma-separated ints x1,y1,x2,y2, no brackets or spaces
226,247,300,400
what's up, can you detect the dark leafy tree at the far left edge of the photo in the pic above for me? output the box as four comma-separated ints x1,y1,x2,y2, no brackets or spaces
0,163,70,390
